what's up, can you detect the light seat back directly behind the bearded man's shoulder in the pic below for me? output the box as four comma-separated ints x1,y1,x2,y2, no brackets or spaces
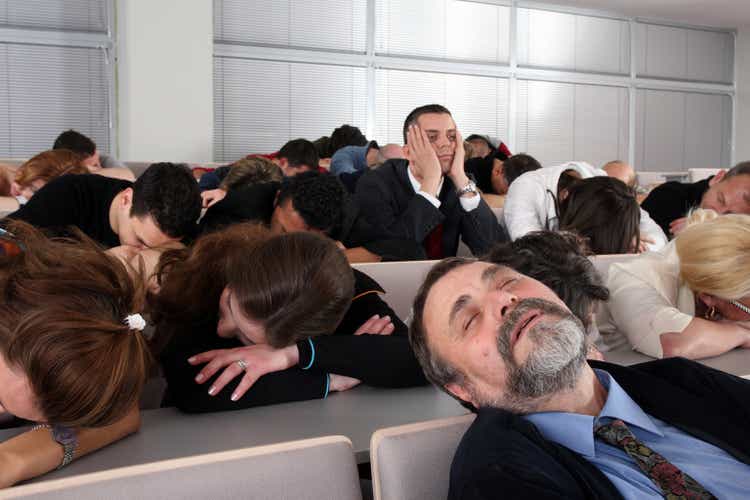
370,414,474,500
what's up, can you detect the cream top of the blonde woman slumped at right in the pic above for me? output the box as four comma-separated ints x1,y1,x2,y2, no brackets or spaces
596,242,695,358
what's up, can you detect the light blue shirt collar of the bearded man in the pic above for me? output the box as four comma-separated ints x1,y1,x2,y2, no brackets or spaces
524,369,664,457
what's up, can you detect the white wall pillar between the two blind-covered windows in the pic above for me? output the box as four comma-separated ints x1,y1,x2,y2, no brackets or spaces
116,0,214,161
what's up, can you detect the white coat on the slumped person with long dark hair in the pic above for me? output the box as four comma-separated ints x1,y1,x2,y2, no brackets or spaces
503,161,667,250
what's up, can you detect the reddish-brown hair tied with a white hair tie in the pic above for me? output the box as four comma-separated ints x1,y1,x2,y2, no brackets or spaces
0,221,150,427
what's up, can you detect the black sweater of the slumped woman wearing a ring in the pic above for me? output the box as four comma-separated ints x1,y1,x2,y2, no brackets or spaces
160,270,427,413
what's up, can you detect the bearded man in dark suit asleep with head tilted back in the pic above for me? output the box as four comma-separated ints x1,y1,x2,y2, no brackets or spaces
409,258,750,499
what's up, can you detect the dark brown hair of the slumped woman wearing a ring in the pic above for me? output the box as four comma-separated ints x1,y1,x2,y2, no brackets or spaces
153,223,354,351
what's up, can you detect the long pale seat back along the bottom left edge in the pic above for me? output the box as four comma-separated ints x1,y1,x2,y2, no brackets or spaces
0,436,362,500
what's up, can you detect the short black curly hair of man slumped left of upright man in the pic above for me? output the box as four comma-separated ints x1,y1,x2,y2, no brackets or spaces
278,172,347,234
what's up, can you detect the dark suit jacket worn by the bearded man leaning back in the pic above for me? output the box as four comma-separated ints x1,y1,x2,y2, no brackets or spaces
448,358,750,500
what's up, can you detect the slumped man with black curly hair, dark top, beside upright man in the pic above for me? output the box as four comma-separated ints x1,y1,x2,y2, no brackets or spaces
201,172,423,262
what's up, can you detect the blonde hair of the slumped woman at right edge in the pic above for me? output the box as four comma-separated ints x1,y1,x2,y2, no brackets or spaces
675,210,750,300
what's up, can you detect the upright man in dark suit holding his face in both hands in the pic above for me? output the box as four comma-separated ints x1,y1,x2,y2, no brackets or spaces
356,104,508,259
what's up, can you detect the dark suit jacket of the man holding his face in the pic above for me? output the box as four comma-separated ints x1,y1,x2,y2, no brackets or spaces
356,160,509,257
